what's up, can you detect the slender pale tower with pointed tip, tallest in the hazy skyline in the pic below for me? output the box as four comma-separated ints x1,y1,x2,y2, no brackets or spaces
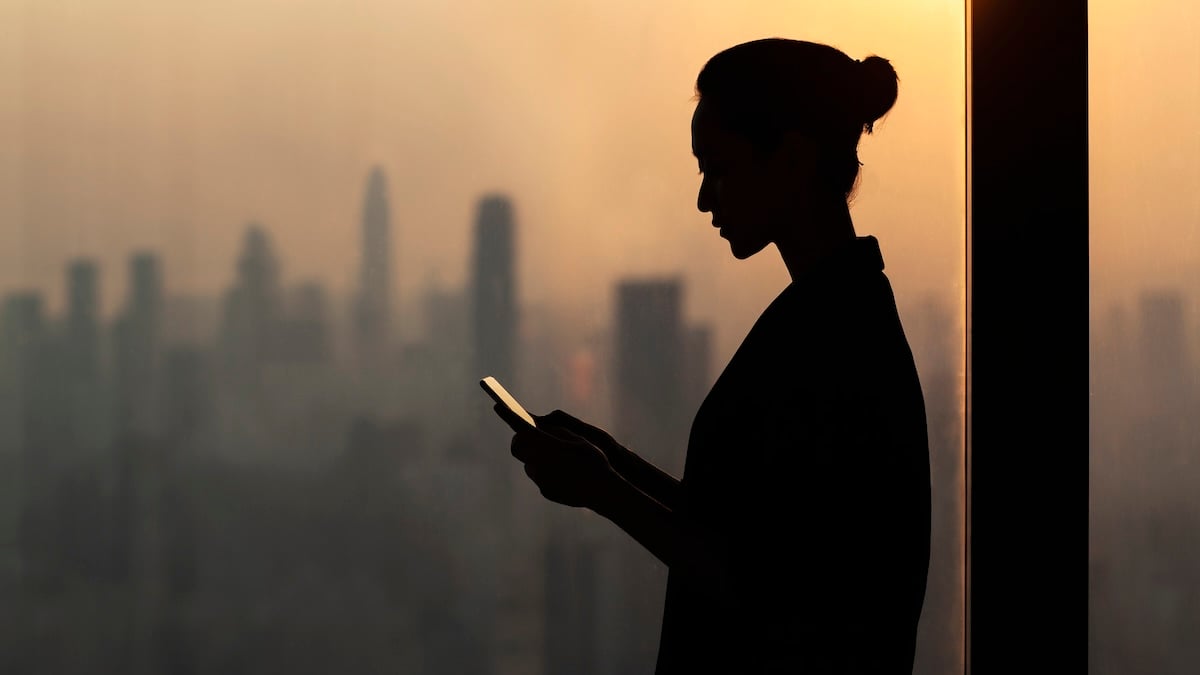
354,167,391,369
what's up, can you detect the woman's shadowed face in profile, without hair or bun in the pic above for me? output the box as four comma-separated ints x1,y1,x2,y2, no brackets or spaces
691,100,800,259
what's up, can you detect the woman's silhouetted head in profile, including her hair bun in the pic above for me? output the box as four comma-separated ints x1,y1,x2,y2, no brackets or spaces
692,38,898,258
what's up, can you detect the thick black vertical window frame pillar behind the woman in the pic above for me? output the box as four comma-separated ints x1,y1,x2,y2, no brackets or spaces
964,0,1090,674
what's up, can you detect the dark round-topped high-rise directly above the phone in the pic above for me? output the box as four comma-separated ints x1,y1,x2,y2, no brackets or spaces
470,195,520,386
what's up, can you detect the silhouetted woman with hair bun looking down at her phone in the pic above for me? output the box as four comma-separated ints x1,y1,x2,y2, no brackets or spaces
497,38,930,675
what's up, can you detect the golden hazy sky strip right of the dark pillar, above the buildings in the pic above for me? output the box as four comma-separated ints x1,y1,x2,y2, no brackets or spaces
1088,0,1200,303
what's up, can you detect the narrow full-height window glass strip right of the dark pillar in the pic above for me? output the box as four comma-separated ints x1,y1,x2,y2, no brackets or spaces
1088,0,1200,674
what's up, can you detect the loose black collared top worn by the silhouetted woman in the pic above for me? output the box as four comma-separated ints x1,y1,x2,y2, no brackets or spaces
656,237,930,675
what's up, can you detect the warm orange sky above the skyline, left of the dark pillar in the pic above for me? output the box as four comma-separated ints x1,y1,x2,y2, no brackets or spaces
0,0,964,356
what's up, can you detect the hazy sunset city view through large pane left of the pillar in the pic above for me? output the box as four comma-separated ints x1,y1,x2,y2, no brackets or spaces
0,0,964,674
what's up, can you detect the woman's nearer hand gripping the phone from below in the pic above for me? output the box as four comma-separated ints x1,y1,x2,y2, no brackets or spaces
497,406,617,510
